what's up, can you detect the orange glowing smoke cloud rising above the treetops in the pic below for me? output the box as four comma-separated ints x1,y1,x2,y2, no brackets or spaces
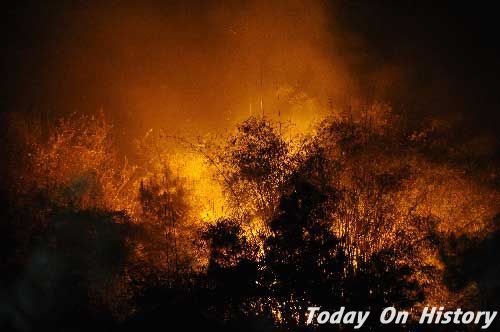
6,0,356,145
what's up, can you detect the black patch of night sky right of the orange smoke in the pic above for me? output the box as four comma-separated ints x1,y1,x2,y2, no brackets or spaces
336,1,500,128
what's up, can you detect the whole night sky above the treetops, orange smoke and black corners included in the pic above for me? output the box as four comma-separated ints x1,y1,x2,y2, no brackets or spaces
1,0,500,143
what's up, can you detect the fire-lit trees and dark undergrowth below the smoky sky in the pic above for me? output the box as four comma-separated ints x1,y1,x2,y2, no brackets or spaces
2,103,499,330
